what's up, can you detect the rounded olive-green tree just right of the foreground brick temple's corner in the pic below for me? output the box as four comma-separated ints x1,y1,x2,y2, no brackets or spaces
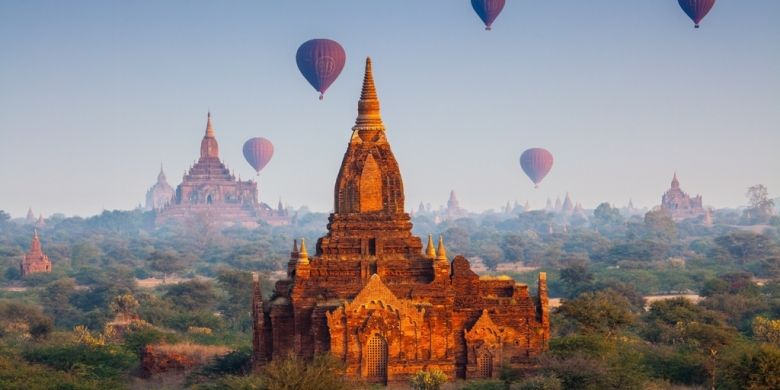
558,290,636,337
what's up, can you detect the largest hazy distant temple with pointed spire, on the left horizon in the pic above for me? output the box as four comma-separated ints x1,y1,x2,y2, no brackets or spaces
156,113,290,228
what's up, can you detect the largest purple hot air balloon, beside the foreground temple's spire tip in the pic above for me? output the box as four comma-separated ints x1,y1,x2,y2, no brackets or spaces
295,39,347,100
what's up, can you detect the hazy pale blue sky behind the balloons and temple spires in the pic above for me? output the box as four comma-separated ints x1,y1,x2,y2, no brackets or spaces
0,0,780,217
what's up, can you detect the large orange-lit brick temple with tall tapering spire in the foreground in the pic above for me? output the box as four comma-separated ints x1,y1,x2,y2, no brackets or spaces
252,59,550,384
